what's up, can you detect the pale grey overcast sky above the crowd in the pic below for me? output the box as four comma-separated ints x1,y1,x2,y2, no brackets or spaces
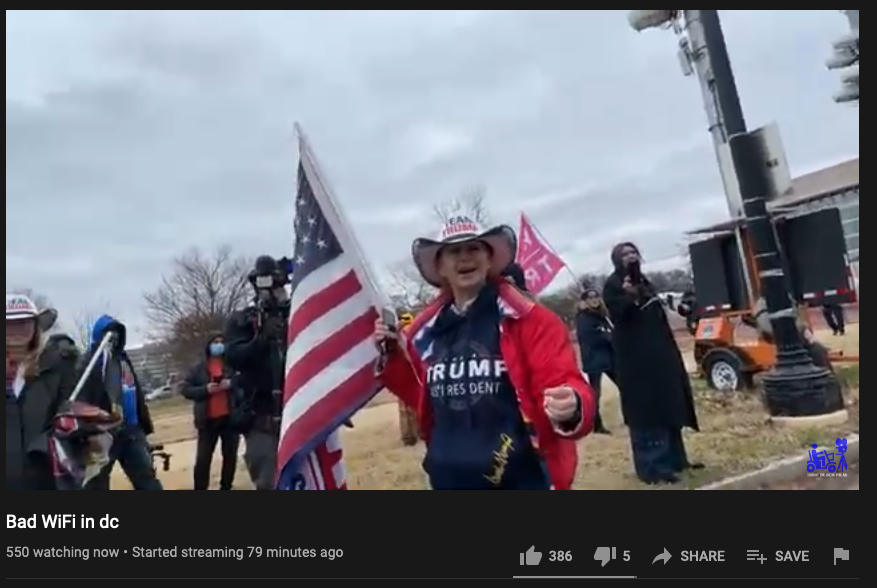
6,10,859,344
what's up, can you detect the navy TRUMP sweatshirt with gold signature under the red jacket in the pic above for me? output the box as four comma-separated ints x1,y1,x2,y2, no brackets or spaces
424,292,550,490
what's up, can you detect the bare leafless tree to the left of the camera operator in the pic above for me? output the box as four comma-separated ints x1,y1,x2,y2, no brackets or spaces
143,247,252,364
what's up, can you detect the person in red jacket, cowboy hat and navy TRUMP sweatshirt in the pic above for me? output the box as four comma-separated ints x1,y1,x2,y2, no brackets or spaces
375,216,595,490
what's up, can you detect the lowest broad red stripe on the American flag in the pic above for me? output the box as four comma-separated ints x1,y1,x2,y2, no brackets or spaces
280,360,375,466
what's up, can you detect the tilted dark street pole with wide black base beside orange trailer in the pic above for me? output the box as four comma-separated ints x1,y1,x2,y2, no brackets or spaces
628,10,845,421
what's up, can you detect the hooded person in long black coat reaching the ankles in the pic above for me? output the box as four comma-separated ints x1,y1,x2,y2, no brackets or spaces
603,243,702,484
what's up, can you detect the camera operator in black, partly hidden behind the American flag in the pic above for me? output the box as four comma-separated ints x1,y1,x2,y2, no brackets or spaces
225,256,290,490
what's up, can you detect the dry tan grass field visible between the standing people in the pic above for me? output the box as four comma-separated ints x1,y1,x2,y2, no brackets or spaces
116,325,859,490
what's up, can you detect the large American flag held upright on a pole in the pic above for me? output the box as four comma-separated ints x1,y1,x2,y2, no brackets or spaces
277,133,380,490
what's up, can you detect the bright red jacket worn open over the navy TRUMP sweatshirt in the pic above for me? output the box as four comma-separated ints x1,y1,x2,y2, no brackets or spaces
378,282,597,490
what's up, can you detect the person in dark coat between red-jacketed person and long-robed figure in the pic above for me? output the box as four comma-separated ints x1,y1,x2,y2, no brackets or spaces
576,288,618,435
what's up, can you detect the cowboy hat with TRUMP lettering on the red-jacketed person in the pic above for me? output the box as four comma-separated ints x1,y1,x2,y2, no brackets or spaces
411,215,518,288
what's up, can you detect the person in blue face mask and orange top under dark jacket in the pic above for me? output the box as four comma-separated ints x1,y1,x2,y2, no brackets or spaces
182,334,240,490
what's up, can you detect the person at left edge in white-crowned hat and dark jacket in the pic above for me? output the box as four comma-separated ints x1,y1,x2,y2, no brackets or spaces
6,294,77,490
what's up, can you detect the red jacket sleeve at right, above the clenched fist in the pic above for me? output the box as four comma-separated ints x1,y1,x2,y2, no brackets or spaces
524,306,597,439
